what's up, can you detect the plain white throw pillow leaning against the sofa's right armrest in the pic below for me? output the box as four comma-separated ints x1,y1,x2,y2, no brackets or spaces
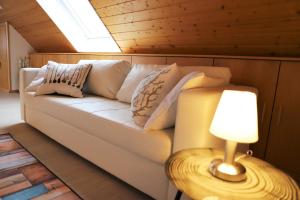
144,72,229,130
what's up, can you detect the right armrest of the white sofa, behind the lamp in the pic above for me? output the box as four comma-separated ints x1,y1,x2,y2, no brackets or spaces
173,87,225,152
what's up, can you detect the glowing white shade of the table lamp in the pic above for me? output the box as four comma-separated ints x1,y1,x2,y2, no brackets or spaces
209,90,258,143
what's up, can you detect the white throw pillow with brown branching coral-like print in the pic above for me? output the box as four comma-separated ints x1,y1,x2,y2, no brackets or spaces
131,64,180,127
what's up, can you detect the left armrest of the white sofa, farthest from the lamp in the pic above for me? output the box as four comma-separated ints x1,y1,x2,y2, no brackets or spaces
19,68,40,120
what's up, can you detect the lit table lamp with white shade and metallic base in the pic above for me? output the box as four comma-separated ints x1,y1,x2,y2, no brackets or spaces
209,90,258,182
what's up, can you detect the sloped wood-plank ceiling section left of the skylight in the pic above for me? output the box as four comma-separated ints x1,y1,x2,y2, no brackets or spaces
0,0,75,52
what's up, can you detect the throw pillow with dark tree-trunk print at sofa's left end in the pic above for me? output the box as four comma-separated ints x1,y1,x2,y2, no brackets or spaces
35,61,92,97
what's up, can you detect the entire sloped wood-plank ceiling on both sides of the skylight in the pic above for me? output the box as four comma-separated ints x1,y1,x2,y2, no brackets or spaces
0,0,300,57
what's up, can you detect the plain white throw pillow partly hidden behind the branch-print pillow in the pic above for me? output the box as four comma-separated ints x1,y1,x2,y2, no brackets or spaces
117,64,168,103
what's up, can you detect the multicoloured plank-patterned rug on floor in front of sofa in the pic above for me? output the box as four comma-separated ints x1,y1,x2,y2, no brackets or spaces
0,134,80,200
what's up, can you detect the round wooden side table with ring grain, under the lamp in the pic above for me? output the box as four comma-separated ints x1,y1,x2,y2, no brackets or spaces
165,149,300,200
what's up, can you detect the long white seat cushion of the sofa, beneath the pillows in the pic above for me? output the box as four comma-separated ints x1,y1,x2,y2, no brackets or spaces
24,92,174,164
